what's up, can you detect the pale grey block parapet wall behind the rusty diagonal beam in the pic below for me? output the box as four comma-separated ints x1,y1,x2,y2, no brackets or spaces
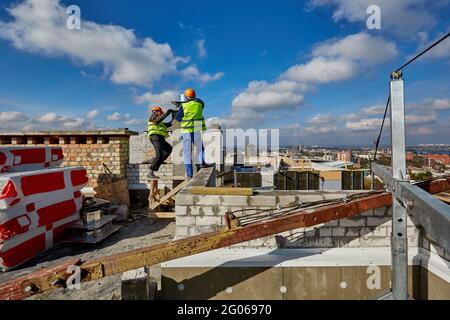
175,169,450,260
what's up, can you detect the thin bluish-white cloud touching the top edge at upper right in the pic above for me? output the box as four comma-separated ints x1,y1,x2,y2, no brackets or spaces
309,0,440,36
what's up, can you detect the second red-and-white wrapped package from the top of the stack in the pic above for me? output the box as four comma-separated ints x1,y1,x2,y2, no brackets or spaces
0,167,89,210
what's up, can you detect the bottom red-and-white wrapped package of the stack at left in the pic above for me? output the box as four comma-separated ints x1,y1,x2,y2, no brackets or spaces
0,213,79,271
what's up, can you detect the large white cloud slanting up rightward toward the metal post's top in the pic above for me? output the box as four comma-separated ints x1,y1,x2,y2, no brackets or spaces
230,32,398,127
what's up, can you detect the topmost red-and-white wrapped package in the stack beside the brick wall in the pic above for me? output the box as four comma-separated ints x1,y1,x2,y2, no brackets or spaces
0,147,64,173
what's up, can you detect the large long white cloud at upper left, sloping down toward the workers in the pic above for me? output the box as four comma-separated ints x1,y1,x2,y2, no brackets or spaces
0,0,220,85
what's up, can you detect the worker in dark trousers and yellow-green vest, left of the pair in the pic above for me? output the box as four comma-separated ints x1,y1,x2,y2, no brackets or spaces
143,106,173,179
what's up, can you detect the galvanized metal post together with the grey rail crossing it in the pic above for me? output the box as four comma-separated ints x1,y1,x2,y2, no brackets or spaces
372,72,450,300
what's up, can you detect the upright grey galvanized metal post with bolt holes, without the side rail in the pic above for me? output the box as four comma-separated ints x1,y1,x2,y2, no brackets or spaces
390,73,408,300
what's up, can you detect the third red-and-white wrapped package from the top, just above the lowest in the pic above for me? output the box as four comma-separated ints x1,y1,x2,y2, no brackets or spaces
0,191,83,241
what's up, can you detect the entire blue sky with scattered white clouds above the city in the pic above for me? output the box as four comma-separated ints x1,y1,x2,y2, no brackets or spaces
0,0,450,144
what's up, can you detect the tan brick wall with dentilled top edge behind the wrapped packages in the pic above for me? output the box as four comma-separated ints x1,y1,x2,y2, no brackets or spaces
0,129,135,187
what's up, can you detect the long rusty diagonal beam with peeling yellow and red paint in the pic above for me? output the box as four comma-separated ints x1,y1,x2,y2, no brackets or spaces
0,192,392,300
